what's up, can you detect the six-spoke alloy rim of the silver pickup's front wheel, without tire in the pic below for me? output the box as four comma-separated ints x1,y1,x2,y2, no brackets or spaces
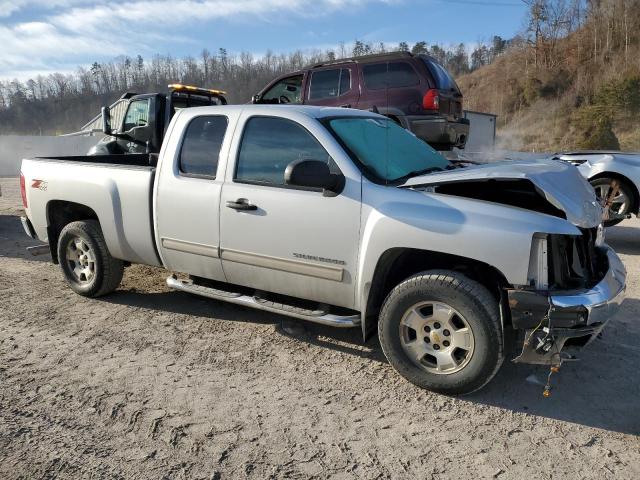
400,302,475,375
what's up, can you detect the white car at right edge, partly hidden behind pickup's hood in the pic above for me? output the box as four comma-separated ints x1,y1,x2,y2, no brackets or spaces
552,151,640,227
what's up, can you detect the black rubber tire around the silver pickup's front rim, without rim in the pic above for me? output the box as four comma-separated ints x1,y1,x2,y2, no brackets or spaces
378,270,504,395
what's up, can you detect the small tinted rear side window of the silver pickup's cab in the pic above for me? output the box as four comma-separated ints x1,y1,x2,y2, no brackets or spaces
178,115,229,178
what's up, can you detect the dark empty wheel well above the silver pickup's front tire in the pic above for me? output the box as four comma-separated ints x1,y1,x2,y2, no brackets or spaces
363,248,511,337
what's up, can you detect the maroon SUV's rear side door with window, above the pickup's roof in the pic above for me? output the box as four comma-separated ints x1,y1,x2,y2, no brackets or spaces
305,64,360,108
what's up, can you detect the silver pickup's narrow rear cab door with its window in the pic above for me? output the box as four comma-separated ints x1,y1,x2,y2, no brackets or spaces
154,111,230,281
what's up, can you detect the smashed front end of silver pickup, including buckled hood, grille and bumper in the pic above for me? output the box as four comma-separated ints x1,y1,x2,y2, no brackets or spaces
404,161,626,368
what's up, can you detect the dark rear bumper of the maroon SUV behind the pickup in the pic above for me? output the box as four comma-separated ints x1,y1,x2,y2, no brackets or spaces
405,115,469,148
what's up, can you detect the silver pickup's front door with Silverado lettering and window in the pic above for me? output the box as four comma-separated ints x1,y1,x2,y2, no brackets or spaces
220,113,361,307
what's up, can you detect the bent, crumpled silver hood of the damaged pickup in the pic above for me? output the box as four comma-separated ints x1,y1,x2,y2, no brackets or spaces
402,160,603,228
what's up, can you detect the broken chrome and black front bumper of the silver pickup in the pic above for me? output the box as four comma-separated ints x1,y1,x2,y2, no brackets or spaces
507,247,627,365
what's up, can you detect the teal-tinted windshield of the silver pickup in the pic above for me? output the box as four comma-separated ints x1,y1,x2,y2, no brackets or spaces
328,117,451,183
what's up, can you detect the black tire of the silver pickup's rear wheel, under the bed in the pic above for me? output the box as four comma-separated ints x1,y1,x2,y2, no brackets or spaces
58,220,124,297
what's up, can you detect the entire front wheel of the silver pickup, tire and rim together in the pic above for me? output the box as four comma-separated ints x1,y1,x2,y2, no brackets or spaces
378,270,504,395
